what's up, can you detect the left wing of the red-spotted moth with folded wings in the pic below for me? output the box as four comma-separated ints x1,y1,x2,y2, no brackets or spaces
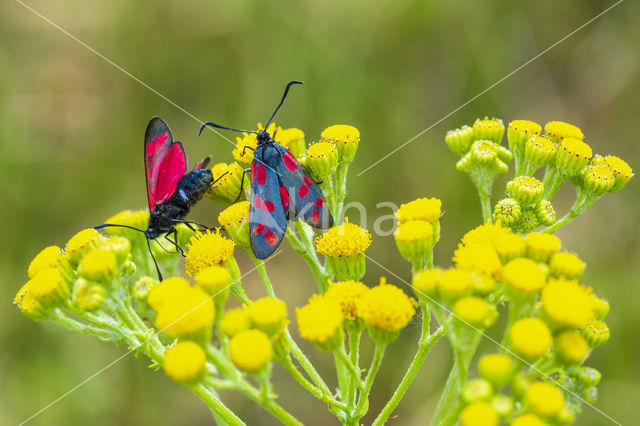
249,153,287,259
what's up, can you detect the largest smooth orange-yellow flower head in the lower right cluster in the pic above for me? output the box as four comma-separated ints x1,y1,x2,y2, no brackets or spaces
540,278,594,328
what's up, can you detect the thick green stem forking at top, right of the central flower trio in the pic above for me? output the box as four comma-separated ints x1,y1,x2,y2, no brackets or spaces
372,314,444,426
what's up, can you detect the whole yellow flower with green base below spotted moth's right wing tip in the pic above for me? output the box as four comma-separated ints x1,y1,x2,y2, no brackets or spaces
315,218,371,281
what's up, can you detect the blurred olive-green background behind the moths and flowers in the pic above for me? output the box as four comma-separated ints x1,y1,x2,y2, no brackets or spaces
0,0,640,425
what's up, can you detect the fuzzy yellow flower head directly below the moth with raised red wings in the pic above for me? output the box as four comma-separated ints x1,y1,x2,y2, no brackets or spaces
184,230,235,276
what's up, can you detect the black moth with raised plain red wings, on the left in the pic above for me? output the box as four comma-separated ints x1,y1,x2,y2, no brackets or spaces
94,117,222,279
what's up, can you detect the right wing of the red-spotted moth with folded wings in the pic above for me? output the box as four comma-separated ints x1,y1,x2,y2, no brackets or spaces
276,145,333,229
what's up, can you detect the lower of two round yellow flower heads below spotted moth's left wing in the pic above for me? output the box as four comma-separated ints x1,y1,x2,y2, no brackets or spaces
229,329,273,373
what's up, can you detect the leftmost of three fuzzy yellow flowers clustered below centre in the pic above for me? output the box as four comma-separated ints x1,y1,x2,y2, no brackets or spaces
296,295,344,352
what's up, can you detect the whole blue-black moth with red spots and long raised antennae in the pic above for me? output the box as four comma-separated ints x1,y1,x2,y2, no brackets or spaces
200,81,333,259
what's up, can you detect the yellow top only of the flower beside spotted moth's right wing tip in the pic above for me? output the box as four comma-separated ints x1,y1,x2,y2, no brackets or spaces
315,218,371,257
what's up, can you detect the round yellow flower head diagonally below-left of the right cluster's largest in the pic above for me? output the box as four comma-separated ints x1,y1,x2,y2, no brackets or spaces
509,318,551,360
